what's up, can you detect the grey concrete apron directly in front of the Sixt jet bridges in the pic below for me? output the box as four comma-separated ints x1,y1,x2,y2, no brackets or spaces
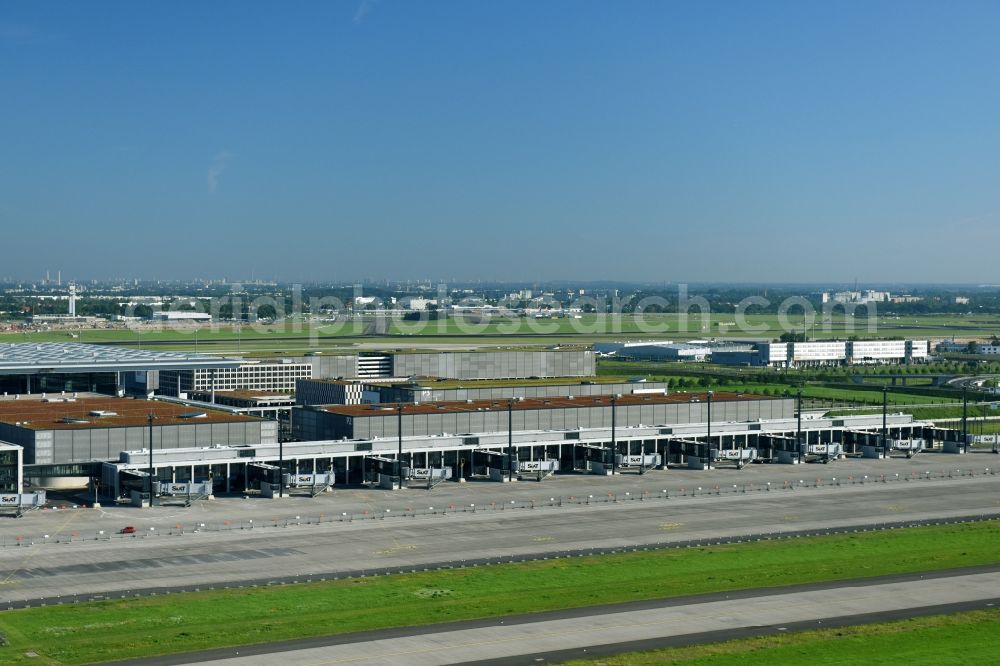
0,452,1000,550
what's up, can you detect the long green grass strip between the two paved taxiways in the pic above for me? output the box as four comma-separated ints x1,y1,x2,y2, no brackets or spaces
0,521,1000,664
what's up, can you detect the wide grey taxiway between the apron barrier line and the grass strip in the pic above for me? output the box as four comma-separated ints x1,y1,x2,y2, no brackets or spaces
0,466,1000,605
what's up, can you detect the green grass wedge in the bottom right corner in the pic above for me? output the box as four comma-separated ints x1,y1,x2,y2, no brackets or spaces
564,608,1000,666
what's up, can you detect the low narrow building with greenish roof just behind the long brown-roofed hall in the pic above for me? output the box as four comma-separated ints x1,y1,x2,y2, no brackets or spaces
295,377,667,405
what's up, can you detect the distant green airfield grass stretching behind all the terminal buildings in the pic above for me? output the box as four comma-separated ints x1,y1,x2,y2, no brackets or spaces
0,311,1000,353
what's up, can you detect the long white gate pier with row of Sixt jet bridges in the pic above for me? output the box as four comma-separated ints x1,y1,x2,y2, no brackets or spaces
100,414,955,496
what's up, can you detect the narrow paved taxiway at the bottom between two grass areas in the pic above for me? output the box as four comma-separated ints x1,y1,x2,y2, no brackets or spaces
127,570,1000,666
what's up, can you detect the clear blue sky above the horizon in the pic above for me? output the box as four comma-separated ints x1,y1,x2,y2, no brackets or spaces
0,0,1000,283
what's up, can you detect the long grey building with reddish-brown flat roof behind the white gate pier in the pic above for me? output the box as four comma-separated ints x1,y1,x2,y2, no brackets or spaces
292,392,795,440
